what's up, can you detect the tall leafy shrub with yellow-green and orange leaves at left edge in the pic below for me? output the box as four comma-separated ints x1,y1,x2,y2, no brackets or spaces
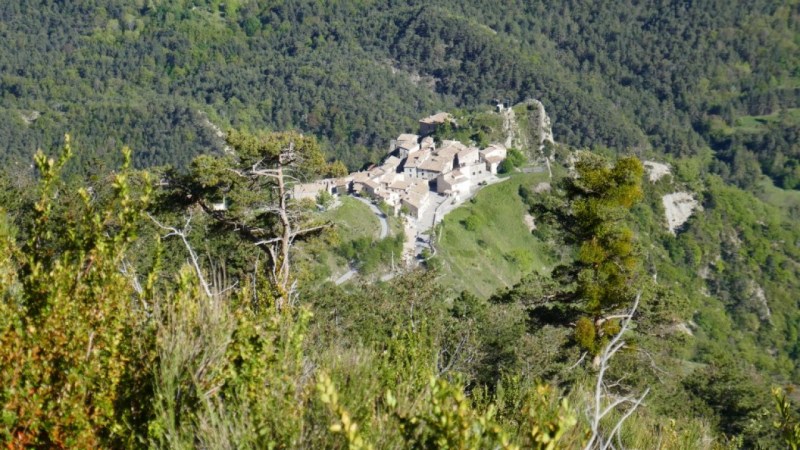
0,137,149,448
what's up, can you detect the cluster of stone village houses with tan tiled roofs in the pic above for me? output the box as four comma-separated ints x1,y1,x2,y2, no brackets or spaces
293,113,506,217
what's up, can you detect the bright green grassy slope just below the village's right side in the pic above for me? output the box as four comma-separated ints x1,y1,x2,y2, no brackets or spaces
436,173,550,297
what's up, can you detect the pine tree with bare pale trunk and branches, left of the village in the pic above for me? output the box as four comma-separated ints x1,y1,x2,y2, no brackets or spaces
165,130,332,308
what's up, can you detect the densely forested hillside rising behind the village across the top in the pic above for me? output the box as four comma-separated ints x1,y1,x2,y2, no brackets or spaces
0,0,800,183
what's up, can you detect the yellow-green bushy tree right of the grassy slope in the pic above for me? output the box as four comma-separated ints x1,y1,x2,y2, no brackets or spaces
533,152,643,318
